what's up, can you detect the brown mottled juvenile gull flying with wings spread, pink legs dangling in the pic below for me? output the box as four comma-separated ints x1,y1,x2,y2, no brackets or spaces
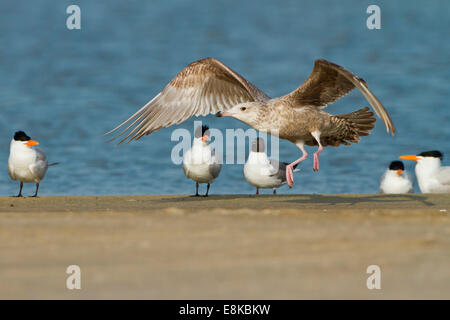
107,58,395,186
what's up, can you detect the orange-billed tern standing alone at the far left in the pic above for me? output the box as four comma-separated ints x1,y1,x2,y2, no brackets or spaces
8,131,57,197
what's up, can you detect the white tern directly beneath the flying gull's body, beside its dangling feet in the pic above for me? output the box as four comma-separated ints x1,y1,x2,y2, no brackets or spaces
244,138,296,195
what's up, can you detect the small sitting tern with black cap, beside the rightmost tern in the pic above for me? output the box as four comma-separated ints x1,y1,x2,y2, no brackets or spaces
380,161,413,194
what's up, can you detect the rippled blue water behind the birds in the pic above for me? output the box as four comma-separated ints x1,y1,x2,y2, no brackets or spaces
0,0,450,196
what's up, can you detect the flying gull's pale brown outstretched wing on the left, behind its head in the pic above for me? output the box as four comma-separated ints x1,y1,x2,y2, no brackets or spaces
107,58,269,143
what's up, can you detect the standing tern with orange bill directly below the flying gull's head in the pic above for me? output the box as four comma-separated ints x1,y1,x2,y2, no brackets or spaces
183,126,222,197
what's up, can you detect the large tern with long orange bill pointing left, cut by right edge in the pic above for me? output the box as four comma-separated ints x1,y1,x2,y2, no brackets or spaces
400,150,450,193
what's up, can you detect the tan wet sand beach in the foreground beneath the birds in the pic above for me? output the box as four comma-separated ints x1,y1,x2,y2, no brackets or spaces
0,195,450,299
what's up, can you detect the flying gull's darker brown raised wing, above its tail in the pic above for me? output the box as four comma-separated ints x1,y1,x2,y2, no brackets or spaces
284,59,395,135
